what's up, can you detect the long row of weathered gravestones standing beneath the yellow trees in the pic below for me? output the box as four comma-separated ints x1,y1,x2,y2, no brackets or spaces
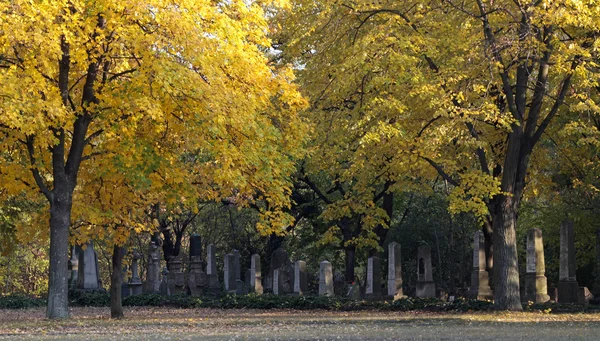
69,221,591,303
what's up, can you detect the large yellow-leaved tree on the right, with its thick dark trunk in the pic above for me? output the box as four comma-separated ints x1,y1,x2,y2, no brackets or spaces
279,0,599,310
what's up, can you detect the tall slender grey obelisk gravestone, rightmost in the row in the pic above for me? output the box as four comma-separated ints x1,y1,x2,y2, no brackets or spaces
558,220,579,303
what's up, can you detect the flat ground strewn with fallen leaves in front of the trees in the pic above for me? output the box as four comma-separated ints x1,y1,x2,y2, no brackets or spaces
0,307,600,340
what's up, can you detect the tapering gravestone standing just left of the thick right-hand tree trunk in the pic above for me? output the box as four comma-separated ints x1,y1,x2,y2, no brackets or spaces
467,231,494,300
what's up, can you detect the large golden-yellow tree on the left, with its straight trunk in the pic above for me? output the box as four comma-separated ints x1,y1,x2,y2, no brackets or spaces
0,0,306,318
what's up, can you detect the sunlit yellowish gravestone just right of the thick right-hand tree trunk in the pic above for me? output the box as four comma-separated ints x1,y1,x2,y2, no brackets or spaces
523,229,550,303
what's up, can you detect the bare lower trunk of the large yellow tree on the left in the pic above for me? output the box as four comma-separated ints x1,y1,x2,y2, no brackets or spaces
46,189,72,319
